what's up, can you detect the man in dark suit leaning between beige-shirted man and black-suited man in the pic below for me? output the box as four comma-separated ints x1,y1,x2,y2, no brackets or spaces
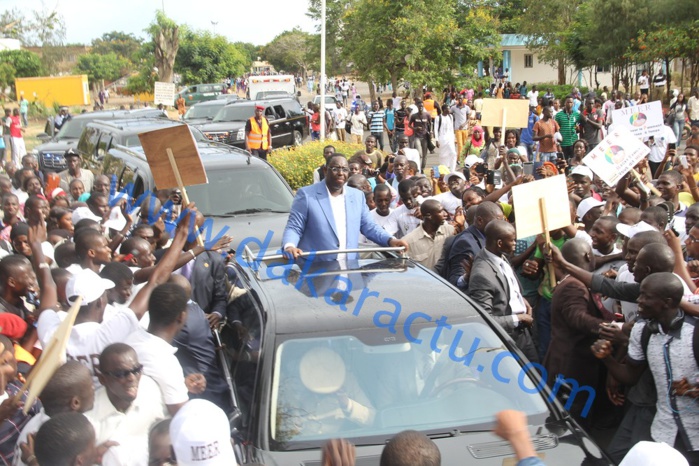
442,201,505,291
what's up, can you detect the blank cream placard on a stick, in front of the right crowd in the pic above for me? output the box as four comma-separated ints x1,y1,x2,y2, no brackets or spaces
512,175,571,239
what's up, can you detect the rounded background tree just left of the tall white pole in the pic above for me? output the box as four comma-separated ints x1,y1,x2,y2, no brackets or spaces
261,28,313,76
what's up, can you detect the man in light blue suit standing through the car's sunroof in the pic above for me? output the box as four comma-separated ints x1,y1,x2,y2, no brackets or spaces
282,154,408,260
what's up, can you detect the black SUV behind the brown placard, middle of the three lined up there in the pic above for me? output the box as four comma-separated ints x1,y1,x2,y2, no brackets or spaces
78,117,209,169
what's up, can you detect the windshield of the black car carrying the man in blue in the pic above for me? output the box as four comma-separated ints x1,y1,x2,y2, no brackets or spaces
270,319,549,450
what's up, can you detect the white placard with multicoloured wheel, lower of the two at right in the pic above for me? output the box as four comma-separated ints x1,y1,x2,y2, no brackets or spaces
583,127,650,186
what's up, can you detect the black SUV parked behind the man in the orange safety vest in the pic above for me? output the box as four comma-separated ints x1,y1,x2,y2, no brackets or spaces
197,98,308,149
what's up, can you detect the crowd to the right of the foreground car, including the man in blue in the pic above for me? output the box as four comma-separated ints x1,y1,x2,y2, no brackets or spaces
283,86,699,464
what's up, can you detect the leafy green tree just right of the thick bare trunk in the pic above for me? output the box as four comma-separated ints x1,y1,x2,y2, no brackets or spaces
175,30,247,84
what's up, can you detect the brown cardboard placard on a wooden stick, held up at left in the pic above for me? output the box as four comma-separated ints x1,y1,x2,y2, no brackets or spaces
138,125,209,189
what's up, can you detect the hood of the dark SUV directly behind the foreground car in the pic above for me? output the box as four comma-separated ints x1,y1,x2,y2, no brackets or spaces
204,212,289,257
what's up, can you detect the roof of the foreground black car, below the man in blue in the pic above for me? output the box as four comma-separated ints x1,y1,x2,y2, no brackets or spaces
252,257,482,339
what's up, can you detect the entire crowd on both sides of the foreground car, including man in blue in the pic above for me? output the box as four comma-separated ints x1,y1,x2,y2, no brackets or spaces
0,76,699,466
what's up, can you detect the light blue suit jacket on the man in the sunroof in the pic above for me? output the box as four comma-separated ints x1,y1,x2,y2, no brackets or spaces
282,181,392,260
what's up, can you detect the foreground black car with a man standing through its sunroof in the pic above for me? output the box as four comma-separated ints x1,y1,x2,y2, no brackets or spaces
227,253,611,466
